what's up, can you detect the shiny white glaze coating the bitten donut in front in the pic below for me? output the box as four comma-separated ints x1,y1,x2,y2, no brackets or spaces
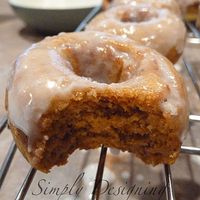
8,32,187,140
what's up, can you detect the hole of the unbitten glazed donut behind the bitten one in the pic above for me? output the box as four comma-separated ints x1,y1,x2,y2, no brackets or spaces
120,8,158,23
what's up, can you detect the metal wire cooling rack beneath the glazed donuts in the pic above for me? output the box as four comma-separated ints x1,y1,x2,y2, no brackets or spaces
0,7,200,200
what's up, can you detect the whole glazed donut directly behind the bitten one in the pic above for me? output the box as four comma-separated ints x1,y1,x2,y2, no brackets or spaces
86,4,186,63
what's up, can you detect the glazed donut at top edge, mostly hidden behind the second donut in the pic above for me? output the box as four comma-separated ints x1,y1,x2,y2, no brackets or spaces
103,0,181,16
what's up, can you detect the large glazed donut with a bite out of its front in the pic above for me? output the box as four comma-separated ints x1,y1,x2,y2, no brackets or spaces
7,32,188,172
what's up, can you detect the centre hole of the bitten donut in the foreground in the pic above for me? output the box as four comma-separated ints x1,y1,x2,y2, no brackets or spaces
70,46,128,84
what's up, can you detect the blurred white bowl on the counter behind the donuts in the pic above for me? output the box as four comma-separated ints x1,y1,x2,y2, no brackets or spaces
9,0,102,33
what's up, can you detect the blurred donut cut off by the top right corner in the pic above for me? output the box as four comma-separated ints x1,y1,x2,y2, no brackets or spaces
177,0,200,21
